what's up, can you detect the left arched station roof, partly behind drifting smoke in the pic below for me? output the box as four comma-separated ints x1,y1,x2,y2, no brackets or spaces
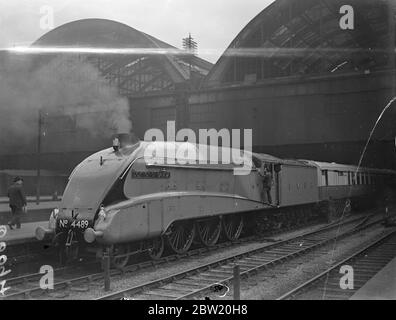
32,19,212,95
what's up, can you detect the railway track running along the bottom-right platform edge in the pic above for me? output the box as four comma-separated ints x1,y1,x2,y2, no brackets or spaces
277,229,396,300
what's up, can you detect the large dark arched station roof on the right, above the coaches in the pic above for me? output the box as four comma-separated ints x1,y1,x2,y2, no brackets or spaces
204,0,396,86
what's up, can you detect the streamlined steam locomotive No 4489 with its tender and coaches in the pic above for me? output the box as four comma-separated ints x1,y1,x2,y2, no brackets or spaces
36,135,396,267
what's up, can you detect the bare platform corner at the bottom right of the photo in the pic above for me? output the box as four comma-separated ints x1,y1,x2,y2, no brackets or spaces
350,258,396,300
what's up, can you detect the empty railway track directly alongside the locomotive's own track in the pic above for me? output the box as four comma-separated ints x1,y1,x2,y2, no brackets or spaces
94,212,382,300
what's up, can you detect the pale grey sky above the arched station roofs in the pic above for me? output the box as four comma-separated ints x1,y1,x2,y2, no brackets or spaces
0,0,273,62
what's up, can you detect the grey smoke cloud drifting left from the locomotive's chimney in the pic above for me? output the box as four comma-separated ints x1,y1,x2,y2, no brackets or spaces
0,56,132,150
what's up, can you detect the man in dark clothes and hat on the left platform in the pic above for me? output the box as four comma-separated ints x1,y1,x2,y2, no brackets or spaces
7,177,26,230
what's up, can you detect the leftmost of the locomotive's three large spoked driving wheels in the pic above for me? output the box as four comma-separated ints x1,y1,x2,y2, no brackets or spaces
166,222,195,254
